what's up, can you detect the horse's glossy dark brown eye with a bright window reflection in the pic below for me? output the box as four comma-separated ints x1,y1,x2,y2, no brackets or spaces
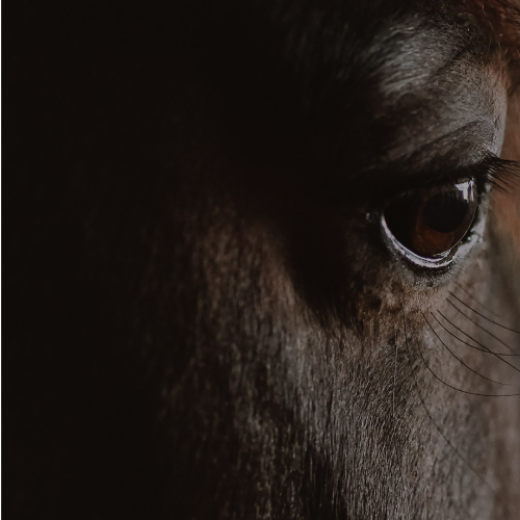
384,180,478,260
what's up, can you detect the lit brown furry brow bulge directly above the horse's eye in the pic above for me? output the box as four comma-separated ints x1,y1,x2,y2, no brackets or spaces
368,22,507,158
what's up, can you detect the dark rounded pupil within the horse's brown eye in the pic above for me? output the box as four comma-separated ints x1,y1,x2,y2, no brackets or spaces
423,191,469,233
